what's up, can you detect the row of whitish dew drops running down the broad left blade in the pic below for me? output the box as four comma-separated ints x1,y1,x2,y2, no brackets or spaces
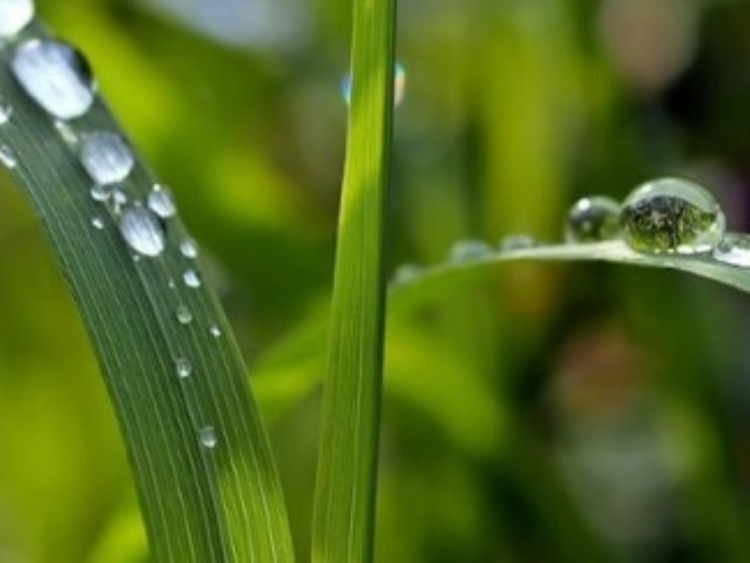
0,0,222,450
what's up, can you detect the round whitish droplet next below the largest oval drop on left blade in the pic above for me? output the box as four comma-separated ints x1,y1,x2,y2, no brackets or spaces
81,131,135,184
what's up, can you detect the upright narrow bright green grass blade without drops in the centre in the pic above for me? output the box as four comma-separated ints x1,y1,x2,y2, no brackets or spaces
313,0,396,563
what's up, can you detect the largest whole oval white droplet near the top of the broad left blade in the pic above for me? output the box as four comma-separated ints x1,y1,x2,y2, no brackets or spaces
11,39,95,119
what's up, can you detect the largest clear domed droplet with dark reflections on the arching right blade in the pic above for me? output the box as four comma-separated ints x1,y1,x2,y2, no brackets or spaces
621,178,725,254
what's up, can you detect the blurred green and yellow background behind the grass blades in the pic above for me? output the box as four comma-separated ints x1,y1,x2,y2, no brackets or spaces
0,0,750,563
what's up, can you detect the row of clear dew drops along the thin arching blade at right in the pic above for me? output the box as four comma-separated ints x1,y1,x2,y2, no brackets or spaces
393,178,750,285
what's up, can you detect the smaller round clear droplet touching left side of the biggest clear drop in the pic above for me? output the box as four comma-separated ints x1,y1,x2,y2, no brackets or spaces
565,196,620,242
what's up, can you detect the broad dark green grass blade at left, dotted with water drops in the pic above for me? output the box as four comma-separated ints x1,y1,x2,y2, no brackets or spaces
0,19,293,563
